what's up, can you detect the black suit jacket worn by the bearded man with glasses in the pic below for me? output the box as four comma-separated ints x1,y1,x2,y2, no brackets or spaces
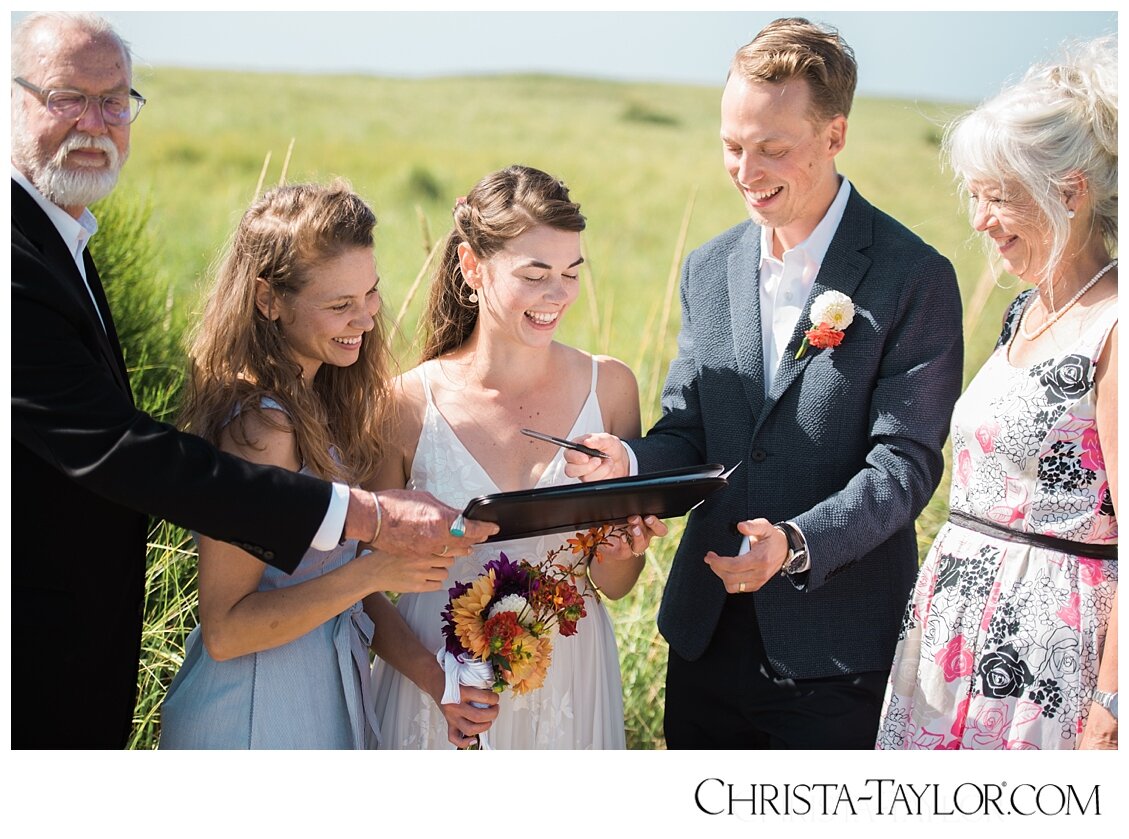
11,181,330,748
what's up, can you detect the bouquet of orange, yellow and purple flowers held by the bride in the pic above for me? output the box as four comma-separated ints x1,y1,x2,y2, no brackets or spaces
437,525,615,749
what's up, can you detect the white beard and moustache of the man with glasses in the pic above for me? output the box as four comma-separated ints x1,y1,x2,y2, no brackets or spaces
11,120,129,207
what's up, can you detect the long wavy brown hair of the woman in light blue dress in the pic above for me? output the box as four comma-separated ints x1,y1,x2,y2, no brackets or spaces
182,181,388,483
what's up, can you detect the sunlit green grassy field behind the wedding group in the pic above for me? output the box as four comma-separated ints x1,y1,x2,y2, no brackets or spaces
110,69,1013,748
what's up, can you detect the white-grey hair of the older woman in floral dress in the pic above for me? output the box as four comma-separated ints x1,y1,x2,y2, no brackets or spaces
944,35,1118,279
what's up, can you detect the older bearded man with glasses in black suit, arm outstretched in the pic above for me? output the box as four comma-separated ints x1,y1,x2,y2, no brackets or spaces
11,14,496,748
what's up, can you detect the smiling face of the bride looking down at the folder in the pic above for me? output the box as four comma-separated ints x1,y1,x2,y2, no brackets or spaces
460,225,584,346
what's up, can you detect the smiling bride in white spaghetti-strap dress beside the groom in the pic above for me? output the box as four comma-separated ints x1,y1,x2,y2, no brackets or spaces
373,166,666,749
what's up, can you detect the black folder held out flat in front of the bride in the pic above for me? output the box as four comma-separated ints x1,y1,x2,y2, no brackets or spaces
463,463,739,542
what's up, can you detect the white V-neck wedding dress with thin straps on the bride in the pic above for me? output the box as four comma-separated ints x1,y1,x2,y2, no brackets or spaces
373,360,625,749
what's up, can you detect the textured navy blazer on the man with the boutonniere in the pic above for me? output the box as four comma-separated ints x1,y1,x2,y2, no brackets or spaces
630,187,963,679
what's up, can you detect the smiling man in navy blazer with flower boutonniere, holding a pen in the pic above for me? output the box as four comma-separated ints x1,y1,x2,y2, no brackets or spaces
566,18,962,749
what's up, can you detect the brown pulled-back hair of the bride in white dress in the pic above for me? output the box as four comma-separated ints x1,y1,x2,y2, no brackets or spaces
420,166,585,361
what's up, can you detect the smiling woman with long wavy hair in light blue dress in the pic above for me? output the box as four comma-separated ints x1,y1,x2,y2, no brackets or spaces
160,183,496,749
